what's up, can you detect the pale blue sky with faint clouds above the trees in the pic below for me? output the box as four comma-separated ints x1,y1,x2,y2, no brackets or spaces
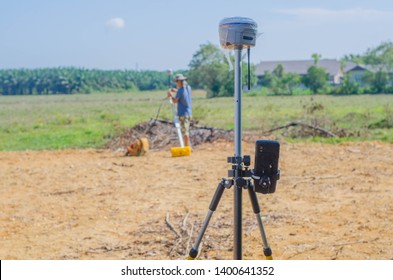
0,0,393,70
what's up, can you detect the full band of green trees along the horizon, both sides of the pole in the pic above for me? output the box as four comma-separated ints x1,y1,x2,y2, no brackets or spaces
0,42,393,97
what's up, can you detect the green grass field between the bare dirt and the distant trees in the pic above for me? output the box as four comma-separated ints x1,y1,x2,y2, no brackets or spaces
0,91,393,151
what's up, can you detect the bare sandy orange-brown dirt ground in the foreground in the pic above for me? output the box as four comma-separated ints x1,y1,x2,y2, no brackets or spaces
0,141,393,260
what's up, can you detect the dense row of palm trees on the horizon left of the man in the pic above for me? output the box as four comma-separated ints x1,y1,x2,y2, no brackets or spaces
0,67,175,95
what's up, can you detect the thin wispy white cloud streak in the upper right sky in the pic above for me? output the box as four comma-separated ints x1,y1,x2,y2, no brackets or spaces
277,8,393,21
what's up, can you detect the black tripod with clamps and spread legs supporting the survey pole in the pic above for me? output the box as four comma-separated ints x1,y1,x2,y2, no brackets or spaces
188,153,272,260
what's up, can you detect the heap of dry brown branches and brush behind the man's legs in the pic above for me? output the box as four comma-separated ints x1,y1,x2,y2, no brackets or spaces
106,119,233,150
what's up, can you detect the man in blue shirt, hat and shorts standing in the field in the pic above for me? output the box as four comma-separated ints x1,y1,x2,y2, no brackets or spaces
168,74,192,146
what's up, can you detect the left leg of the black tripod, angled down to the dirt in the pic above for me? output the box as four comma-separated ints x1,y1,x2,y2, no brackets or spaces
187,179,229,260
